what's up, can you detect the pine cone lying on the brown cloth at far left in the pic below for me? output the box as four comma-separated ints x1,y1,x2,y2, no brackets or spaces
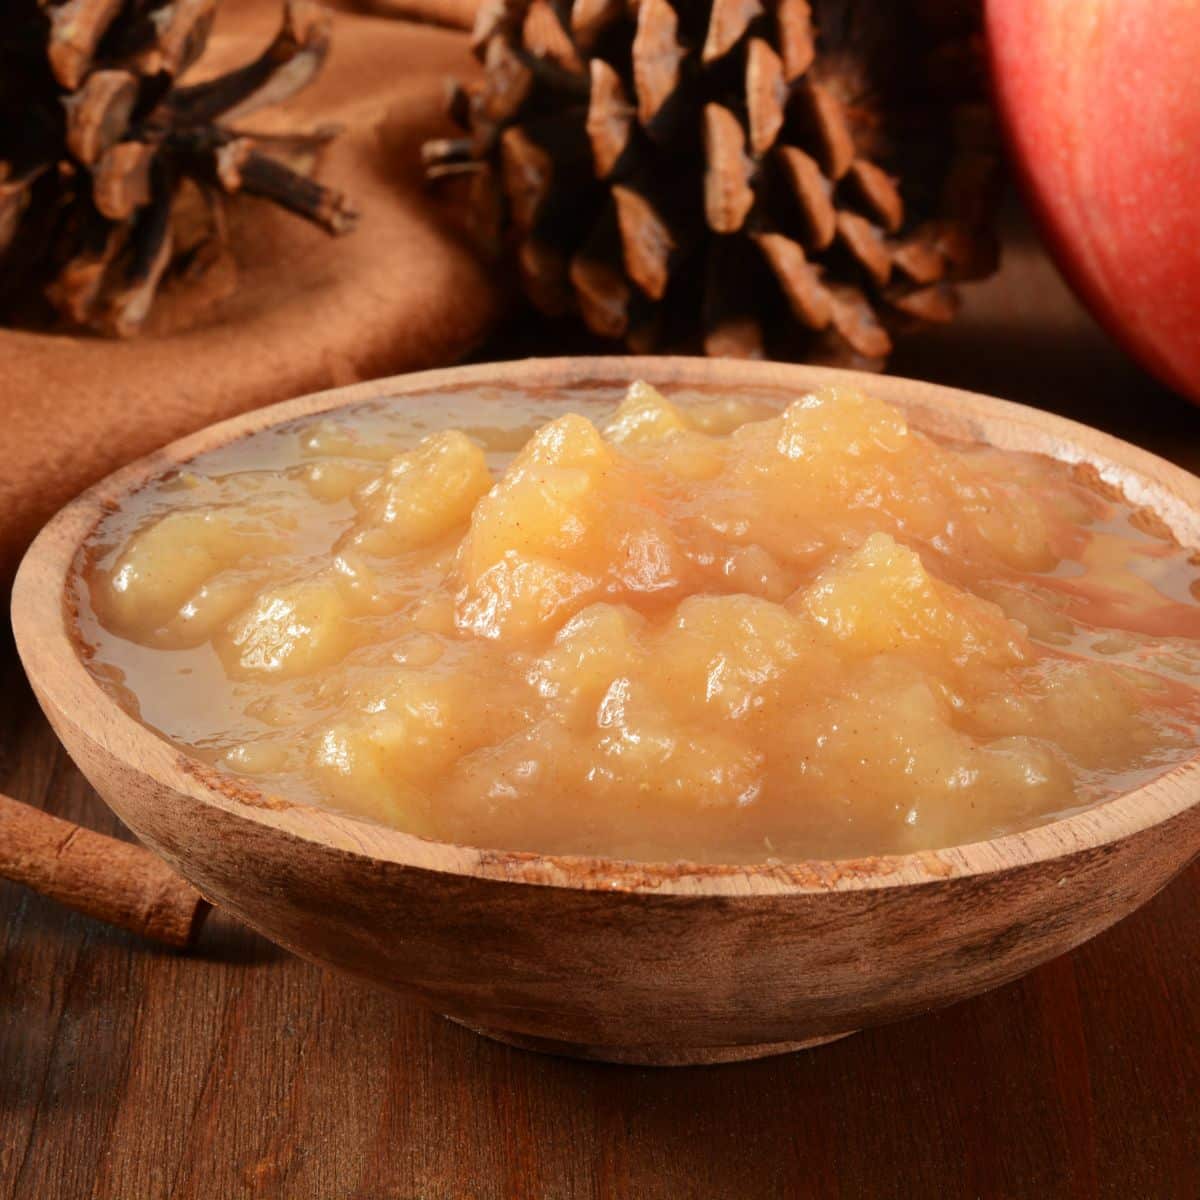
0,0,356,336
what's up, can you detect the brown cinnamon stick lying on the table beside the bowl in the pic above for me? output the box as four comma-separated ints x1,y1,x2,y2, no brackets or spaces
0,794,210,948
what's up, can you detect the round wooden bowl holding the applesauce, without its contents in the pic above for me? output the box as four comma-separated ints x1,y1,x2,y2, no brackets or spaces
13,358,1200,1063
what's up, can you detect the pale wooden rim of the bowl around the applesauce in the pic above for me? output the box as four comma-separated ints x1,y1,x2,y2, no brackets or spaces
12,356,1200,896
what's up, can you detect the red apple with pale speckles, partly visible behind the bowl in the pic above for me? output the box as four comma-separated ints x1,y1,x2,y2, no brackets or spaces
986,0,1200,403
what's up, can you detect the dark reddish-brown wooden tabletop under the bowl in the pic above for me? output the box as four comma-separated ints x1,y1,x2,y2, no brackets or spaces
0,220,1200,1200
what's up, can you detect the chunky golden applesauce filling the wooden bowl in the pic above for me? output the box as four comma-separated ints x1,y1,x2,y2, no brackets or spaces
79,383,1200,863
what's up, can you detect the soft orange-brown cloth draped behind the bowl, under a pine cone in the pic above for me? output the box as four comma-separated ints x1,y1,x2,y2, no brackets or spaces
0,0,498,584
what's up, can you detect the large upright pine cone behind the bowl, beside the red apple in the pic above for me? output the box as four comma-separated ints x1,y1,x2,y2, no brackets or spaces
425,0,997,366
